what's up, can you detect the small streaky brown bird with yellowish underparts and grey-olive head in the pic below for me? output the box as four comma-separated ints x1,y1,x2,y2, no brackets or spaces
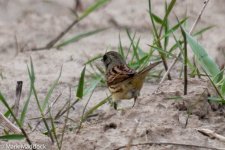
102,51,162,109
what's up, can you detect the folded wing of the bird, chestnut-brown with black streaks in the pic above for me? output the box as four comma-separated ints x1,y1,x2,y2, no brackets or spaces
106,65,136,86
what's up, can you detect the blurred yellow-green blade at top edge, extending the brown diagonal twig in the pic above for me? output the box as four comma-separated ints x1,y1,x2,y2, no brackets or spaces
79,0,110,20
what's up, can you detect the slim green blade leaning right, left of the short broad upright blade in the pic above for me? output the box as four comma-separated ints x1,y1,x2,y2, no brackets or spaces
41,67,62,111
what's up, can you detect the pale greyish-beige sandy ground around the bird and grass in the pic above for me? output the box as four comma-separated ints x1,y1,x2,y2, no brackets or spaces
0,0,225,150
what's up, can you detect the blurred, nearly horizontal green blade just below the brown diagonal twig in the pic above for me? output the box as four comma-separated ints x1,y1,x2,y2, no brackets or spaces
56,28,107,48
